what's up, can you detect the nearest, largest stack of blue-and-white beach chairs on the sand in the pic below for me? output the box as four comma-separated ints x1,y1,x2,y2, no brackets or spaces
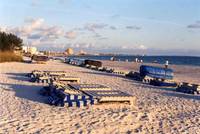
46,82,136,107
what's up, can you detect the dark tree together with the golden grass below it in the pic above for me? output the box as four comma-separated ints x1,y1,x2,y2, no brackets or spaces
0,32,23,62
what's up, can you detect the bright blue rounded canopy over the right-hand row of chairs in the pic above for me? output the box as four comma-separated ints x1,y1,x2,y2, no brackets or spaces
140,65,174,79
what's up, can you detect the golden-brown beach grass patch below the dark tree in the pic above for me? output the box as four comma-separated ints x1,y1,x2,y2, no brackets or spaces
0,51,23,63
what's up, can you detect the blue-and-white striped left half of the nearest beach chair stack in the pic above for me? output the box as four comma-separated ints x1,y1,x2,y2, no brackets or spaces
44,82,98,107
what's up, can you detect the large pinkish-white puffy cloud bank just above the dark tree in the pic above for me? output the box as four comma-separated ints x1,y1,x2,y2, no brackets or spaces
1,18,65,45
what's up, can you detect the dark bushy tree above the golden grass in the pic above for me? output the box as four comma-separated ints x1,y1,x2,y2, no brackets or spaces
0,31,23,51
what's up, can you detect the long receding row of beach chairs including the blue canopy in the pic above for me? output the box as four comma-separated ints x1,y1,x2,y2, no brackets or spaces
65,58,200,94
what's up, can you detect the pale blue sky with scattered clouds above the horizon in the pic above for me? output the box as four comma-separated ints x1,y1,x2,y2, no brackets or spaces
0,0,200,56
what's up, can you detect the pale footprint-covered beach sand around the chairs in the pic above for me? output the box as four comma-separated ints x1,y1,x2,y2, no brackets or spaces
0,61,200,134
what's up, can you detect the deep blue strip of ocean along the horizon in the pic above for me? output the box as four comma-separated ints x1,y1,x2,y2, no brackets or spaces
64,55,200,66
